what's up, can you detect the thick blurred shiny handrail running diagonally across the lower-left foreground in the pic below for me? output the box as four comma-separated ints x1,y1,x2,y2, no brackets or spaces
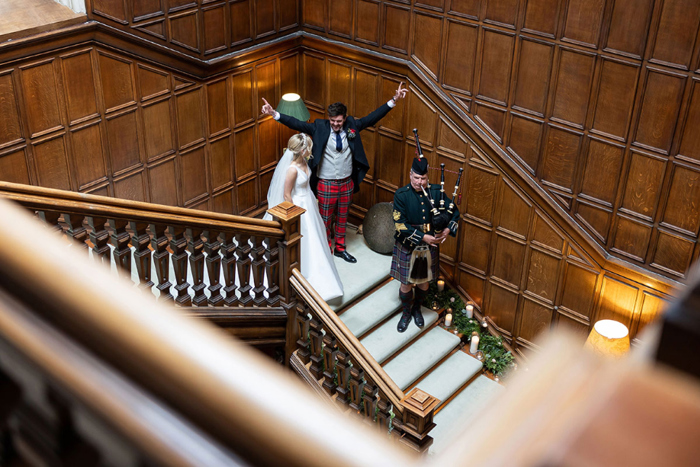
0,196,418,466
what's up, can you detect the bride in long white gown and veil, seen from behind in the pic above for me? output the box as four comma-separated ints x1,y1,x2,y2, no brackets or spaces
264,133,343,301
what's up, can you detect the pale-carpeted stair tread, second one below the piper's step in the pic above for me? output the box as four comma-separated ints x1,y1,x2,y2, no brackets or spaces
417,351,483,402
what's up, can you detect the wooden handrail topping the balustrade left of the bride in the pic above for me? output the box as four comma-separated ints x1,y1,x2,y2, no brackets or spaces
0,182,284,238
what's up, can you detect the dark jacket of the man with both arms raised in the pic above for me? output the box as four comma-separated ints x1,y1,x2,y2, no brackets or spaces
279,104,391,193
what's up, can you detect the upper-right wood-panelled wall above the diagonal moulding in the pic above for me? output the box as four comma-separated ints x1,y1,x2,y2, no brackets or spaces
303,0,700,280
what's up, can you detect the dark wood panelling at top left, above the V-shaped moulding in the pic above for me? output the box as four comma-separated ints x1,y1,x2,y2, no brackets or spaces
87,0,299,60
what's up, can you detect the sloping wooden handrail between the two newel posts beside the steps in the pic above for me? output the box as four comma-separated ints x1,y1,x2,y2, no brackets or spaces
290,269,404,414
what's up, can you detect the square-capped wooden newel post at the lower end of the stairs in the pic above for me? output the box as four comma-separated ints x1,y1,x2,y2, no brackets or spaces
394,388,440,453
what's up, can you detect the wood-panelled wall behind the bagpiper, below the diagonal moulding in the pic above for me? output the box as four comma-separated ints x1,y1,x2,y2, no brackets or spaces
302,51,669,352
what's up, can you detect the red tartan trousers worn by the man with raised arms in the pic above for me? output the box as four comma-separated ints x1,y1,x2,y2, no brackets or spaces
317,177,355,251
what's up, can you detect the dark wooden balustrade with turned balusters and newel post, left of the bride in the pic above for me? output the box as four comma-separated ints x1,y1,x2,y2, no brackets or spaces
0,182,303,361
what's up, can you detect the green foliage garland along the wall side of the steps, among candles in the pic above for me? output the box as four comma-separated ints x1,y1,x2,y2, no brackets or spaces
423,282,516,376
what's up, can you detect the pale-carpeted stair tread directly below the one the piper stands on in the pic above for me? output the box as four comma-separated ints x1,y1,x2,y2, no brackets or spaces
384,327,460,390
